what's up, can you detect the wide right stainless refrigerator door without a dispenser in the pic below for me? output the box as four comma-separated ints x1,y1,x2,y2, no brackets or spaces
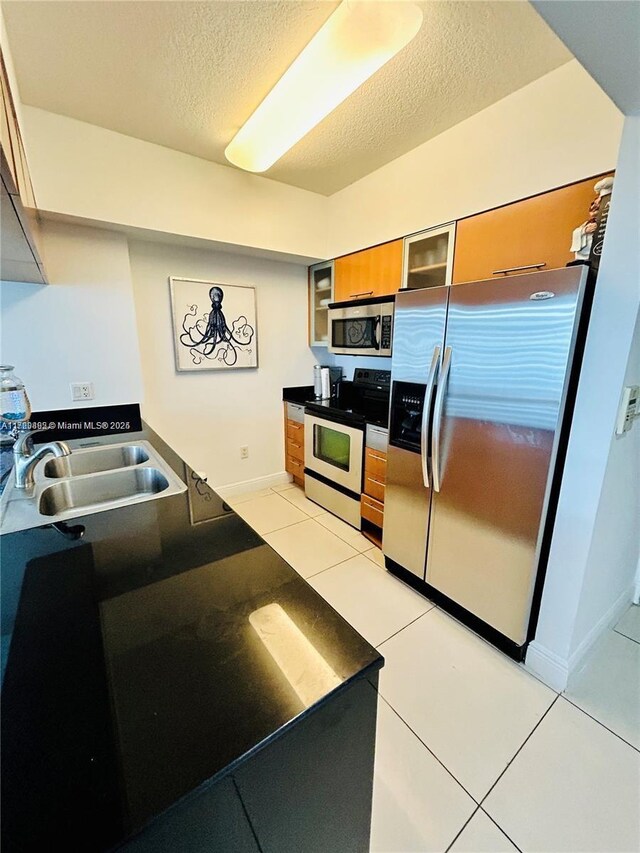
426,267,586,645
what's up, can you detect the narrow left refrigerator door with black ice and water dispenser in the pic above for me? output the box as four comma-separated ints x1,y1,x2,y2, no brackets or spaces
382,287,449,580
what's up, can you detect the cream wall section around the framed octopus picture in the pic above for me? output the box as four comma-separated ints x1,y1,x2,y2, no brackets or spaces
130,236,316,486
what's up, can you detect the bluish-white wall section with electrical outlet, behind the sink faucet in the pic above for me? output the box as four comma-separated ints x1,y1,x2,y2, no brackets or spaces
0,222,142,410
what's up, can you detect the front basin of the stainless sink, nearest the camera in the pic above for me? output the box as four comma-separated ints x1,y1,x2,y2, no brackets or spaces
38,468,169,516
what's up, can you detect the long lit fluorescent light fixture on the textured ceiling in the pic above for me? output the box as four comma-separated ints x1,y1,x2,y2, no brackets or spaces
224,0,422,172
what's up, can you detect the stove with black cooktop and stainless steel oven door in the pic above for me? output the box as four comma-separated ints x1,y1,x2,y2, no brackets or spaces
304,368,391,530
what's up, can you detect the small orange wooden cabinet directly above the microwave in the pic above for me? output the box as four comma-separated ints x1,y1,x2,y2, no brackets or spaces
333,240,403,302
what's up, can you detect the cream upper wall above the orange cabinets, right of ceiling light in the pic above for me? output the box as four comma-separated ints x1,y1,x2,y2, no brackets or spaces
329,61,623,256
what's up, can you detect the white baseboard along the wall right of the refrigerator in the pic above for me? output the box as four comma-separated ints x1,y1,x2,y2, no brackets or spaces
525,586,634,693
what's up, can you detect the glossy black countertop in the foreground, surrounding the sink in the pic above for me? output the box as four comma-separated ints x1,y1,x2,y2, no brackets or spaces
0,429,384,851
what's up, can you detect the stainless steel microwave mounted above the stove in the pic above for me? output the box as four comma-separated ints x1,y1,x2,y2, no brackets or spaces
329,295,396,356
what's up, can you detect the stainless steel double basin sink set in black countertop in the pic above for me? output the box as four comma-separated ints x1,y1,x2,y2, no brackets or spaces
0,441,187,533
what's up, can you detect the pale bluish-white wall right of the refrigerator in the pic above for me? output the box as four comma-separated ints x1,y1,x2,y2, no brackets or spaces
527,117,640,689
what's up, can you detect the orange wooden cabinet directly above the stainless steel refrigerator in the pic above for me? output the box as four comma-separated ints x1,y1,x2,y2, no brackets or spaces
453,177,599,284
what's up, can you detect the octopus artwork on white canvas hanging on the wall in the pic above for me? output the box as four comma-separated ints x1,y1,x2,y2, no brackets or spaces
169,276,258,372
